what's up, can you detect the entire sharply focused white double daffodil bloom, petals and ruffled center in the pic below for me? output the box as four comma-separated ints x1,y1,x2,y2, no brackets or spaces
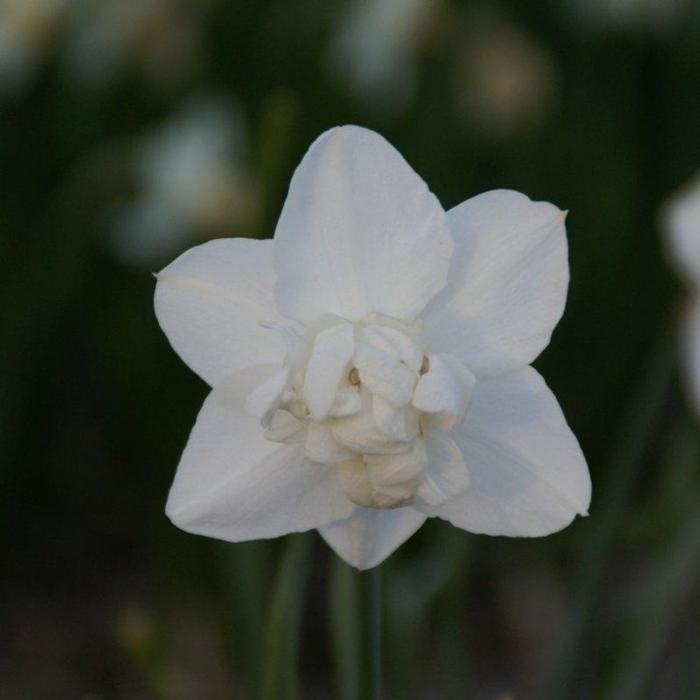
155,126,590,568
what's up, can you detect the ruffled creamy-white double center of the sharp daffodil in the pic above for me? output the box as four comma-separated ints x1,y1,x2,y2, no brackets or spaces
246,314,474,508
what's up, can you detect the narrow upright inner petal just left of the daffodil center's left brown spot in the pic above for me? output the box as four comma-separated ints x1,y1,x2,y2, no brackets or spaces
304,323,355,421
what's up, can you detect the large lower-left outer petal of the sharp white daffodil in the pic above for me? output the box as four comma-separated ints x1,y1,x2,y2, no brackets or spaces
166,367,354,542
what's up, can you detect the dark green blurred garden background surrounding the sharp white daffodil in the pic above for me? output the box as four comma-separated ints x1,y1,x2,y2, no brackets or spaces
0,0,700,700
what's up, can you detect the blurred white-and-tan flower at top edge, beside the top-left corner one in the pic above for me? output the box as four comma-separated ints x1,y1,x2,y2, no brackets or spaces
65,0,208,86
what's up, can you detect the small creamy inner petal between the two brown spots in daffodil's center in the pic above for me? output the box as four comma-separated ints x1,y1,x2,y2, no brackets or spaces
353,344,417,407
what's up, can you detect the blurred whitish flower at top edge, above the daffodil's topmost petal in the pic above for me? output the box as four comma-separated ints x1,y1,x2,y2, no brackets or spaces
329,0,442,110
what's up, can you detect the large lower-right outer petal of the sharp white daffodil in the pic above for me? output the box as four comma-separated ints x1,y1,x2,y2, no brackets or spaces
424,367,591,537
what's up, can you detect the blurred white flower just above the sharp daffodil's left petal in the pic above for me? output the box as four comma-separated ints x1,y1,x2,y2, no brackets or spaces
112,98,258,264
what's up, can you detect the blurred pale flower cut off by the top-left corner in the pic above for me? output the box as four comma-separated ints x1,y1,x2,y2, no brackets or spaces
0,0,74,92
